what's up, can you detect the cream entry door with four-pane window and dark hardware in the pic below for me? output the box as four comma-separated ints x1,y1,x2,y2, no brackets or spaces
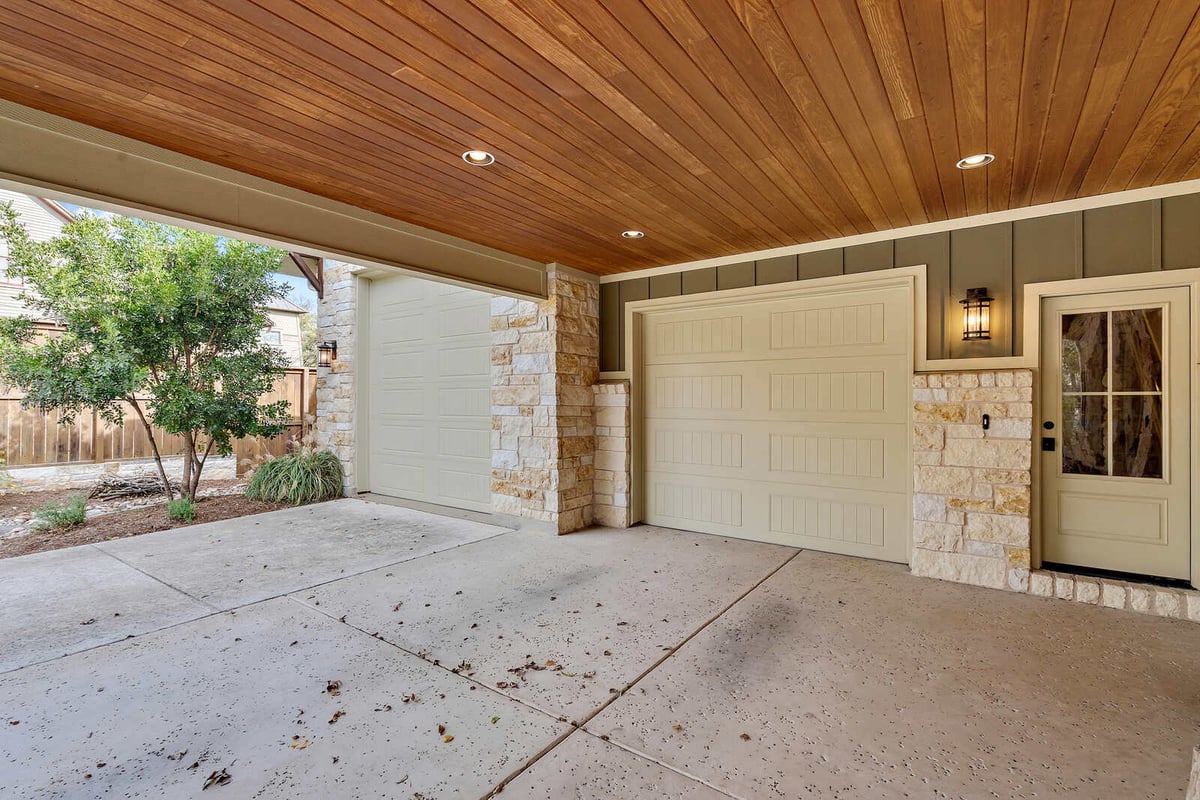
1040,288,1192,579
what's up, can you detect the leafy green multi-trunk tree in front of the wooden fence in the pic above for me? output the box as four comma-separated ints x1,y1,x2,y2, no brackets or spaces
0,204,287,500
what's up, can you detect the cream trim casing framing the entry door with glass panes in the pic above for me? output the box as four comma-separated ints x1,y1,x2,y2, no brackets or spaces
1021,269,1200,587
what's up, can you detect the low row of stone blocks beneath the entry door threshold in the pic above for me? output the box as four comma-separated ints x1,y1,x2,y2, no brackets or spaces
1030,570,1200,622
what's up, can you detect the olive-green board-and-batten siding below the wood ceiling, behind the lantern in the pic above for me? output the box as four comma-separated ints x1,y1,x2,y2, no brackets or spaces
600,194,1200,372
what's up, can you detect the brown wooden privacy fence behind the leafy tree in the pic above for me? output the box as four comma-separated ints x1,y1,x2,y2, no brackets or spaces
0,369,317,475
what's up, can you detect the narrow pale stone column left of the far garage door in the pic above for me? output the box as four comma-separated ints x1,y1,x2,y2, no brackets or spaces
316,261,360,494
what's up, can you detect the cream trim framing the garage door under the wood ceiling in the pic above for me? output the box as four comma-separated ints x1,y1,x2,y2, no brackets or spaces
619,264,926,561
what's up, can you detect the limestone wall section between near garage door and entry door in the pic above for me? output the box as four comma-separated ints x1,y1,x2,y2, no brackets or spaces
912,369,1033,591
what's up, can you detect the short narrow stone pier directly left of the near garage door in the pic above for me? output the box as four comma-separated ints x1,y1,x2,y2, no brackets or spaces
594,380,630,528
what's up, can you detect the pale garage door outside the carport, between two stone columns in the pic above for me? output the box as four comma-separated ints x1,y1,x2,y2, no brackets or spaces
367,277,492,511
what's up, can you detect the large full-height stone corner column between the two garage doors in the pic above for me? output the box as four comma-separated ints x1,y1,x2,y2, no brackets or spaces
492,270,600,534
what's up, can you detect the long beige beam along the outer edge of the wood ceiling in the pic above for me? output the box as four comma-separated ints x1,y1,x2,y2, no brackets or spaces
0,101,546,299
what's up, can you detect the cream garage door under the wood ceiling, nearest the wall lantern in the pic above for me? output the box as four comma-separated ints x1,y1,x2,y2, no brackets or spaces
642,288,912,561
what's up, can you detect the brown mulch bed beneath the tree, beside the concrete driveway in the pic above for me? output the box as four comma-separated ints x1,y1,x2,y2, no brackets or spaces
0,496,297,559
